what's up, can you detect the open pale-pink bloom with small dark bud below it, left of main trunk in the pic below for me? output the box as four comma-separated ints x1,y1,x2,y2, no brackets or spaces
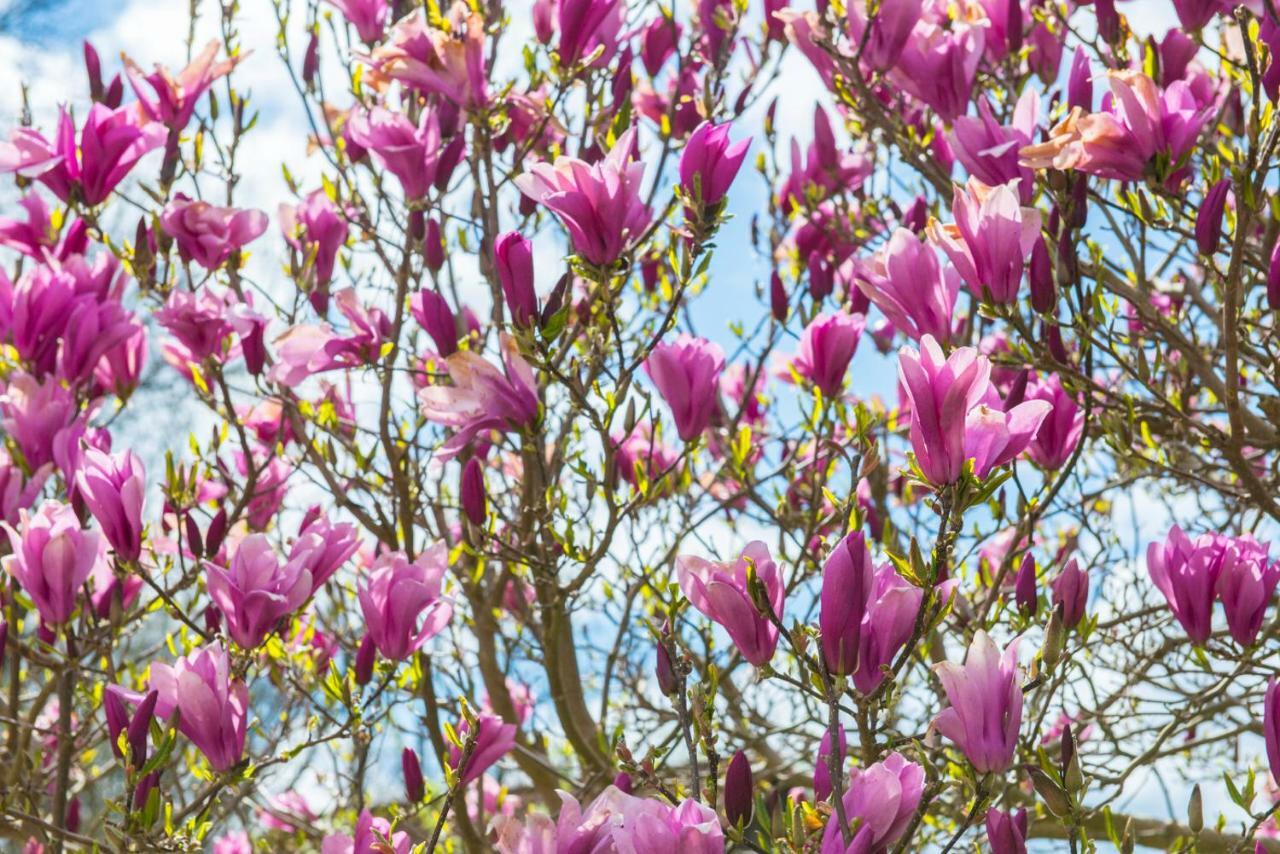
357,542,453,661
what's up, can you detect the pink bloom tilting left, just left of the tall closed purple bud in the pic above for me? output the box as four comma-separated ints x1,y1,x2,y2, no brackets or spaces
676,542,786,667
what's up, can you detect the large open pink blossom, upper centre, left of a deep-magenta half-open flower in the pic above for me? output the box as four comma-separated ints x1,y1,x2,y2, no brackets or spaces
516,128,652,266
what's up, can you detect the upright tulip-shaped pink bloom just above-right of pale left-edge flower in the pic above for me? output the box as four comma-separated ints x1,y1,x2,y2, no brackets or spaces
76,447,147,561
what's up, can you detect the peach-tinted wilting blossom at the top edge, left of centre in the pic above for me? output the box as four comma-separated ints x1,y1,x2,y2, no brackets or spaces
367,3,489,109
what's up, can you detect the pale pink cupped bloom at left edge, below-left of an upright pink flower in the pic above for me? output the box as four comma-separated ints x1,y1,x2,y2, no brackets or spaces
0,501,99,626
